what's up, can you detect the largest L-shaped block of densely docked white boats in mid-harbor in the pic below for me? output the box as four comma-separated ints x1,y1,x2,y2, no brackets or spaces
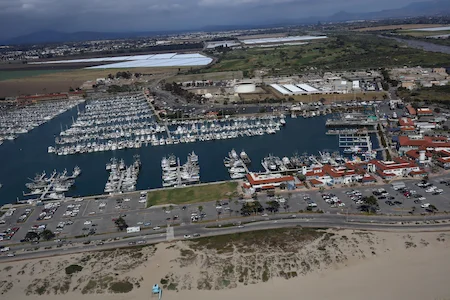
47,94,286,155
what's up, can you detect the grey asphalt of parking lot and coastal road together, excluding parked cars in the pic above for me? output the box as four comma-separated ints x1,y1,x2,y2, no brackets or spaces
0,175,450,259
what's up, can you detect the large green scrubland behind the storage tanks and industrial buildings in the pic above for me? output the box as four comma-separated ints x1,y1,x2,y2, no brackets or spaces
202,32,450,76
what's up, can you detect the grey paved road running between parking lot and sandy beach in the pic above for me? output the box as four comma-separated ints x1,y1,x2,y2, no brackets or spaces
0,214,450,262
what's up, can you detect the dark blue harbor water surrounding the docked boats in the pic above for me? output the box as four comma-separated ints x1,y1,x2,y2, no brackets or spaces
0,108,378,204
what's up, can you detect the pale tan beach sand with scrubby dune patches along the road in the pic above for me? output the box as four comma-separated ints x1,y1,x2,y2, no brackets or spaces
0,229,450,300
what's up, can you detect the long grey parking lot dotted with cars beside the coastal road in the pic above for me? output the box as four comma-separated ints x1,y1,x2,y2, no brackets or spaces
0,176,450,243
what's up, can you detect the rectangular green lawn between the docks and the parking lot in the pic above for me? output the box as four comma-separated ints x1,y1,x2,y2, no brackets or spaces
147,182,237,207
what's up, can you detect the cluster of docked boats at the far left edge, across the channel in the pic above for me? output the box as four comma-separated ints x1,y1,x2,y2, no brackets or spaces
0,99,84,145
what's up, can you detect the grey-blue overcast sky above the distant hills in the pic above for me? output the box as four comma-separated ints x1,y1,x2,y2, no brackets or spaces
0,0,426,39
